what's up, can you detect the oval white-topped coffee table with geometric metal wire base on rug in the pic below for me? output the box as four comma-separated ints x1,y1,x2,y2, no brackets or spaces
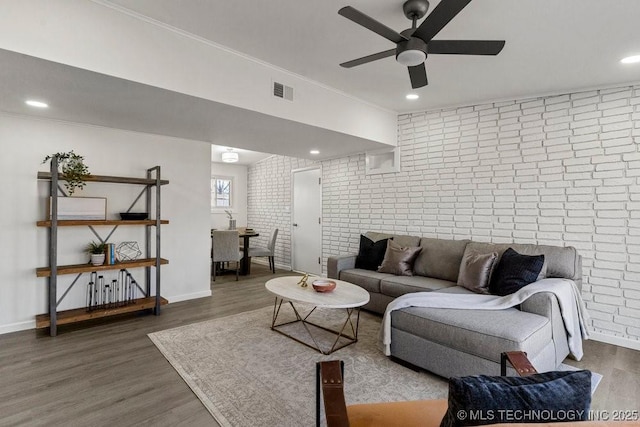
265,276,369,354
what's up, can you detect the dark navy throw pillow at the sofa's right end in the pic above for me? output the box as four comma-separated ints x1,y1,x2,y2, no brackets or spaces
489,248,544,296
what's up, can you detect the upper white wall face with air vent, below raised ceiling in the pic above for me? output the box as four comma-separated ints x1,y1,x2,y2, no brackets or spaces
0,0,396,145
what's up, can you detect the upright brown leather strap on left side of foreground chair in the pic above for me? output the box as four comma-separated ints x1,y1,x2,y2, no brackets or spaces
318,360,349,427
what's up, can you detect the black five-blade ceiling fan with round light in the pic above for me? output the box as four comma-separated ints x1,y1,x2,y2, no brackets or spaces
338,0,504,89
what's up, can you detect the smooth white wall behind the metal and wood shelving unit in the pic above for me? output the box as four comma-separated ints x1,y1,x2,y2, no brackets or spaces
0,114,211,333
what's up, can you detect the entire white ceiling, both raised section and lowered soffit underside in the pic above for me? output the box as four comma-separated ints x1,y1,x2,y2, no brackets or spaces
0,0,640,164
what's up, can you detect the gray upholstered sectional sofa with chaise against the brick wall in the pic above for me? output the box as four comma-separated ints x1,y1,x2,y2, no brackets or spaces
327,232,582,377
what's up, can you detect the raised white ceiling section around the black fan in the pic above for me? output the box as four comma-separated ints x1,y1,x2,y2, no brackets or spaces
103,0,640,112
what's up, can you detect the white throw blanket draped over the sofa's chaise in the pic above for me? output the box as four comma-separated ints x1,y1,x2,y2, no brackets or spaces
380,279,589,360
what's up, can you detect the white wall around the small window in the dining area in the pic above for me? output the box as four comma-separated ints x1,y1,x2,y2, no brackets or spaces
211,162,251,230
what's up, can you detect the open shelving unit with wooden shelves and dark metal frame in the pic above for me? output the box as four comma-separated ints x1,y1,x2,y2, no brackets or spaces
36,158,169,336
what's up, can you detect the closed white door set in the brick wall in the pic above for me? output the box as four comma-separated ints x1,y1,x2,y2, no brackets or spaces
291,169,322,275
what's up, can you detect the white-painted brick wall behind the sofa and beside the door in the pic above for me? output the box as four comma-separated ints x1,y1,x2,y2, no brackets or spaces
249,86,640,348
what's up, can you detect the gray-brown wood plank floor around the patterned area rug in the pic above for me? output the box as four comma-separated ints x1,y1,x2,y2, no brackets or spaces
0,264,640,427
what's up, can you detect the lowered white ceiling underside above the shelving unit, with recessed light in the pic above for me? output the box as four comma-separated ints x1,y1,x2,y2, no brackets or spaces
0,49,385,160
